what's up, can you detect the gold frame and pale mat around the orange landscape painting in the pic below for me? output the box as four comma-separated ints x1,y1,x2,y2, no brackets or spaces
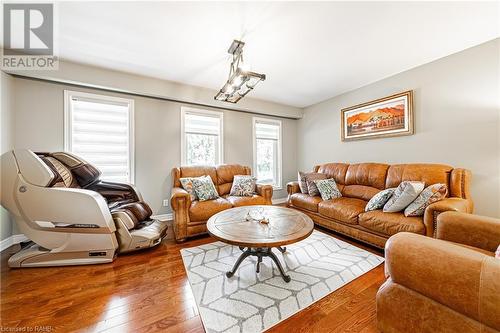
340,90,414,141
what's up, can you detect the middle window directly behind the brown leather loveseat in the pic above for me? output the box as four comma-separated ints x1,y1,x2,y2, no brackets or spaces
181,107,223,165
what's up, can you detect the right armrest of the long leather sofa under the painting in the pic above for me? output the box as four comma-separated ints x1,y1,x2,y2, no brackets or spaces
424,197,472,237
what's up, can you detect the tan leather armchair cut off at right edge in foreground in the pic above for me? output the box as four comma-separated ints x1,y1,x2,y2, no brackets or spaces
377,212,500,333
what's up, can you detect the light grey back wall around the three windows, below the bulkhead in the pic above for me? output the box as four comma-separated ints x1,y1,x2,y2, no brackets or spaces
13,78,297,218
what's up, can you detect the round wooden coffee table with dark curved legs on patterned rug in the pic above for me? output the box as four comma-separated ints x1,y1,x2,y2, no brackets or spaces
207,206,314,282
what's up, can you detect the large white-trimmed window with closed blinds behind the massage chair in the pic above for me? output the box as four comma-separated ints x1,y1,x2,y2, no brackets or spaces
64,90,134,183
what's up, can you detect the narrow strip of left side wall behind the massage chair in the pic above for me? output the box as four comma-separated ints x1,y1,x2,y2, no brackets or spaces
0,72,13,240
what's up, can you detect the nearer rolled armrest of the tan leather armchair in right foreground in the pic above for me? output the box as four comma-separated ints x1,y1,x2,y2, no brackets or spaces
385,232,500,327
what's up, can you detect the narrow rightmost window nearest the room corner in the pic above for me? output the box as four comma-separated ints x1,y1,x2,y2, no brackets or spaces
253,118,281,188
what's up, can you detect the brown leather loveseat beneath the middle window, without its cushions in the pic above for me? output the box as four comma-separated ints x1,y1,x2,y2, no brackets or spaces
170,164,273,242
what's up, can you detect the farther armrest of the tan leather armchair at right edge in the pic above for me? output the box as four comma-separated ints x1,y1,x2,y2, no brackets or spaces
436,212,500,252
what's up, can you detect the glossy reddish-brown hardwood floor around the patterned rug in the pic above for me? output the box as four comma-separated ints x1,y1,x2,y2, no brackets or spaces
0,223,384,333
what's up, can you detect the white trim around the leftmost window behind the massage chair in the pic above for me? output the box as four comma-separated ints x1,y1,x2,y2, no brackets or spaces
63,90,135,184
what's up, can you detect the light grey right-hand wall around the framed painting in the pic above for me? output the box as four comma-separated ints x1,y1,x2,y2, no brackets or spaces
297,39,500,217
